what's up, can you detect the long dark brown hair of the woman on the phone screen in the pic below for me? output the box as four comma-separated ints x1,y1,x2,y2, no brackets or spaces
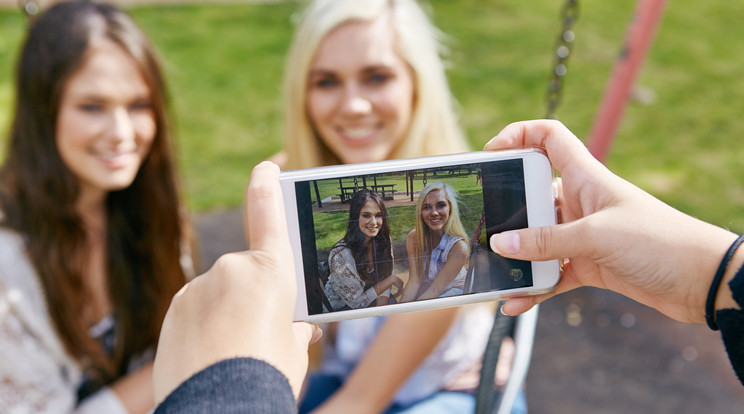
337,189,393,287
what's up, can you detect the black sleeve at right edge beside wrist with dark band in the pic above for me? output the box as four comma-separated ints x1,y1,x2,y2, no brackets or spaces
716,266,744,385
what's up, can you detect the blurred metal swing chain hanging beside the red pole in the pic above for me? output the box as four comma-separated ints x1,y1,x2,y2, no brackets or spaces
545,0,579,119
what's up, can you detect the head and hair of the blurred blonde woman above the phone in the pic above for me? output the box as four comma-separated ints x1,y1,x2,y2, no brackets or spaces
277,0,468,169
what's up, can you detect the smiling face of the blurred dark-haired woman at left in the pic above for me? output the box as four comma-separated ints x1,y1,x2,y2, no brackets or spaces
56,39,156,201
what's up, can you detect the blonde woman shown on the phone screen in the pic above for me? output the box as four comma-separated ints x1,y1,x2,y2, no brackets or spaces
401,181,470,302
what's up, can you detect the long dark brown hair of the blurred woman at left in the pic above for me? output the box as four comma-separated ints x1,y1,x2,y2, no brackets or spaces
0,0,191,384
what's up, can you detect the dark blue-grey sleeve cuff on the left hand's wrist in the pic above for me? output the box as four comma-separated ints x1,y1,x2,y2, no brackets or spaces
155,358,297,414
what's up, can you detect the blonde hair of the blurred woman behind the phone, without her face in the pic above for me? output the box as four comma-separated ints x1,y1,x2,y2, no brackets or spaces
284,0,468,169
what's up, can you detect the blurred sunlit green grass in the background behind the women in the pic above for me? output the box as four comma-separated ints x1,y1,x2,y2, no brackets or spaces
0,0,744,232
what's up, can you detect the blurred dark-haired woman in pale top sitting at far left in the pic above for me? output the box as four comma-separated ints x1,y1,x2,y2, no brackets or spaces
0,0,193,413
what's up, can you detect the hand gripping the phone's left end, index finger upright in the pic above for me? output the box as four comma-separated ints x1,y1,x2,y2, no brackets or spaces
153,162,321,403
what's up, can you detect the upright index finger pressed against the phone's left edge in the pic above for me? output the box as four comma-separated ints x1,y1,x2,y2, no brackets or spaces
244,161,289,252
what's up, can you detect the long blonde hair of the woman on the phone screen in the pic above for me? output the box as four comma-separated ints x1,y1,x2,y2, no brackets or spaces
414,181,470,277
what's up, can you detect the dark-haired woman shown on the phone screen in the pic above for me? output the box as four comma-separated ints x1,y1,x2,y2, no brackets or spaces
325,189,403,311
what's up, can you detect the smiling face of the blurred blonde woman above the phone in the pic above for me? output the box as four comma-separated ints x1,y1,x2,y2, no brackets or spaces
306,17,415,163
